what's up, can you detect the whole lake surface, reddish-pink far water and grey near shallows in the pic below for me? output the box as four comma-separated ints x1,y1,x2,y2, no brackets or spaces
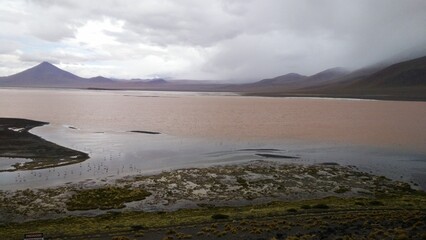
0,89,426,189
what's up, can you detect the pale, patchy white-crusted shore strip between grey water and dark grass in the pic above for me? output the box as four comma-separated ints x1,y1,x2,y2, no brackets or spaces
0,160,424,223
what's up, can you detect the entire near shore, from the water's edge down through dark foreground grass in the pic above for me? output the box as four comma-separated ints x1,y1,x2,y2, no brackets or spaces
0,161,426,239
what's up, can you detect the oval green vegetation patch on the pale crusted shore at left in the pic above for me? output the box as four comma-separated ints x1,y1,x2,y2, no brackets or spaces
66,186,151,211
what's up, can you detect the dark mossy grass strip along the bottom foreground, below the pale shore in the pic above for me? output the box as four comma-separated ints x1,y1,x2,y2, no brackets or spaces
0,192,426,239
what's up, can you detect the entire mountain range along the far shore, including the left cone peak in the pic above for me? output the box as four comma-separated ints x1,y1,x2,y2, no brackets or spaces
0,56,426,101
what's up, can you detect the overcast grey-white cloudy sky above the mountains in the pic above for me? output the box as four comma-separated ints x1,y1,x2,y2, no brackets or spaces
0,0,426,81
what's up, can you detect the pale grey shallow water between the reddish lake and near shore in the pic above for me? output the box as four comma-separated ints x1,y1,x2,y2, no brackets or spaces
0,125,426,189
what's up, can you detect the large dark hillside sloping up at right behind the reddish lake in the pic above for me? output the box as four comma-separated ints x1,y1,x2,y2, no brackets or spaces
246,57,426,101
